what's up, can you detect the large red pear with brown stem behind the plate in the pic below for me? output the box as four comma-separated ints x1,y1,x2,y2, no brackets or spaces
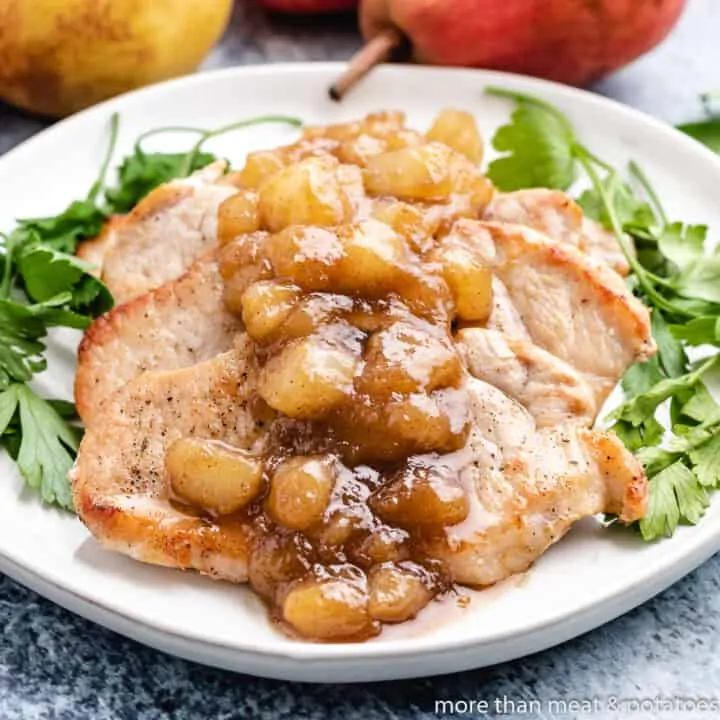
360,0,686,85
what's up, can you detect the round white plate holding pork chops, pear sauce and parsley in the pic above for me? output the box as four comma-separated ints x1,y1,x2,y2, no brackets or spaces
0,64,720,682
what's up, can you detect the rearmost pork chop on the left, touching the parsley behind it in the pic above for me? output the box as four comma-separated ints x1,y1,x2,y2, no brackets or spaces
102,162,237,304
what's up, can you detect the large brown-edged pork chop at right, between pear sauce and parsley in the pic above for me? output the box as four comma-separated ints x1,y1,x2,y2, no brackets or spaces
452,220,655,403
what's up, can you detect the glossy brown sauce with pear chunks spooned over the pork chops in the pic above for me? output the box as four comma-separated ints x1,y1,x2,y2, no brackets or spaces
168,113,492,641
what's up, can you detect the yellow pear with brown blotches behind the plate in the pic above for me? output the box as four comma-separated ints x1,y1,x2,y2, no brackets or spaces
0,0,232,116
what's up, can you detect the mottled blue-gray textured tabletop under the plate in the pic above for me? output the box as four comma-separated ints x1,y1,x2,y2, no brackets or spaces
0,0,720,720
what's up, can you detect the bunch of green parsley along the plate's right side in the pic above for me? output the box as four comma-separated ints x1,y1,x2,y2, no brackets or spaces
486,87,720,540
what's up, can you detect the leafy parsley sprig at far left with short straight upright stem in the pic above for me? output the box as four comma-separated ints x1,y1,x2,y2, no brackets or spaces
0,115,118,510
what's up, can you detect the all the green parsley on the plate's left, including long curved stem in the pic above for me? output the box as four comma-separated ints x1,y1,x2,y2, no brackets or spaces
0,114,302,510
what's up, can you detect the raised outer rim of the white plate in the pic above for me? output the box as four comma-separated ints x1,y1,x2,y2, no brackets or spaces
0,62,720,662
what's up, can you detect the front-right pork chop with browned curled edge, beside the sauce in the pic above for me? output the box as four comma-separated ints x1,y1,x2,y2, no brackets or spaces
423,380,647,587
